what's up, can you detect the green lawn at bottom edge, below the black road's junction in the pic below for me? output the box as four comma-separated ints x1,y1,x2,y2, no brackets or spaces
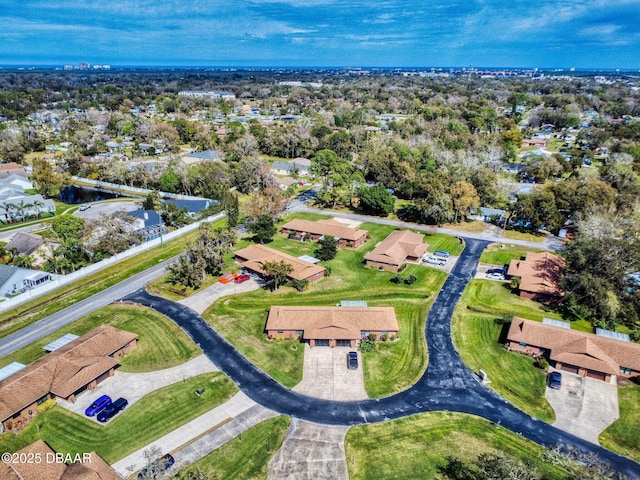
345,412,568,480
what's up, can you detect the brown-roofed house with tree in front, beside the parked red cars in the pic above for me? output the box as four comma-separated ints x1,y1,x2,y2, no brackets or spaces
234,245,326,283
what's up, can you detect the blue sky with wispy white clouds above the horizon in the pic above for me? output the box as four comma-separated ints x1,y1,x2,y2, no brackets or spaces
0,0,640,69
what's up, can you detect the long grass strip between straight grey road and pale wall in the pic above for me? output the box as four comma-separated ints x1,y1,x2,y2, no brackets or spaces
0,219,226,338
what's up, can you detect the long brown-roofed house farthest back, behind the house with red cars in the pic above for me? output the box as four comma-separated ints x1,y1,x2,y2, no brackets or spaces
281,219,369,248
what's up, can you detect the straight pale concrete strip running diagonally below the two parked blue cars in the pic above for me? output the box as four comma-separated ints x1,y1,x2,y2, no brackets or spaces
112,392,260,478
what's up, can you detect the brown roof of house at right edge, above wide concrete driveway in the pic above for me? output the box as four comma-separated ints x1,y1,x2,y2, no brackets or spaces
507,317,640,375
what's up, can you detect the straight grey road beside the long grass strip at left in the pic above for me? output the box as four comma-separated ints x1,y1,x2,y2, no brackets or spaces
0,260,172,357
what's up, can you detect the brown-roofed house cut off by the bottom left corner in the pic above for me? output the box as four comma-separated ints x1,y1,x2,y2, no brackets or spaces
0,440,122,480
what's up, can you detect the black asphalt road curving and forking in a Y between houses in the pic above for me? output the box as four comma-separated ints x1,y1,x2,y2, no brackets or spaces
124,239,640,478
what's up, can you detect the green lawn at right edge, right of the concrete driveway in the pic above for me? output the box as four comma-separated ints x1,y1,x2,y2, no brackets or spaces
599,383,640,462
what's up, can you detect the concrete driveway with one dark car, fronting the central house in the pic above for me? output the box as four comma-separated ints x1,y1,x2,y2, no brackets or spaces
293,344,369,401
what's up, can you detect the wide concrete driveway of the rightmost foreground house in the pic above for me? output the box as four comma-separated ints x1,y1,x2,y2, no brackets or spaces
545,372,620,444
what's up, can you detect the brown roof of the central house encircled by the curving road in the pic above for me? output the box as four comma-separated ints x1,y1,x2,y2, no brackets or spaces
266,306,398,340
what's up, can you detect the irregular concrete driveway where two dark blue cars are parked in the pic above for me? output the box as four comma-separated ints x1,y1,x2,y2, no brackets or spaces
58,355,218,425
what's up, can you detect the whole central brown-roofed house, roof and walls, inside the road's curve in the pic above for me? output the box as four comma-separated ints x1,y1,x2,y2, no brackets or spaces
265,306,398,348
